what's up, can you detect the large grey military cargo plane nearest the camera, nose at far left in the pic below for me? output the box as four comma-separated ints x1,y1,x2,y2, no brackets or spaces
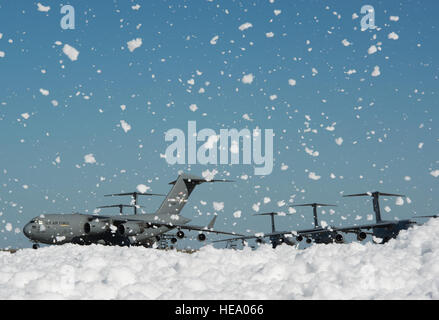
23,174,242,249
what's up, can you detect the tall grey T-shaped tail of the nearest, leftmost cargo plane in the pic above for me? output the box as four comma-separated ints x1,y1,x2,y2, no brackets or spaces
155,173,234,215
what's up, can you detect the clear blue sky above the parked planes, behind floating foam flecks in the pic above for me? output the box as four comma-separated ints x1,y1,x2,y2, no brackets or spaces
0,0,439,247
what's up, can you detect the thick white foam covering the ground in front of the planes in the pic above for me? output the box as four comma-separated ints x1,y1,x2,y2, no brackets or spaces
0,219,439,299
